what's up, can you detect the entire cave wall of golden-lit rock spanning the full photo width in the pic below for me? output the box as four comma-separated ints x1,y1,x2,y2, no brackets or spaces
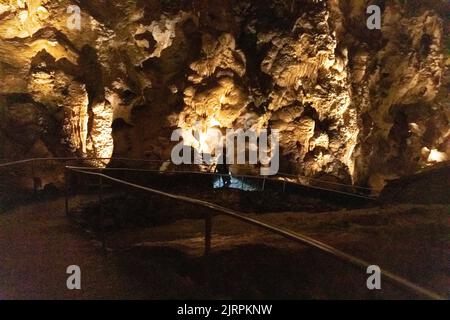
0,0,450,187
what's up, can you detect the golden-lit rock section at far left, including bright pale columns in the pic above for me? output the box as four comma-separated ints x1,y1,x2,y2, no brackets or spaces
0,0,113,162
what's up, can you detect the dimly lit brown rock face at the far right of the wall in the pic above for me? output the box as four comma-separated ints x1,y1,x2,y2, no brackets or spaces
351,2,450,187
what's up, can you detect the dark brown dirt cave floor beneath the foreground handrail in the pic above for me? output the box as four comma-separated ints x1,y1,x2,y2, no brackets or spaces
0,189,450,299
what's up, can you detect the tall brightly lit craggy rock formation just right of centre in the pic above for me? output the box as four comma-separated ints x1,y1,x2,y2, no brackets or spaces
260,6,359,182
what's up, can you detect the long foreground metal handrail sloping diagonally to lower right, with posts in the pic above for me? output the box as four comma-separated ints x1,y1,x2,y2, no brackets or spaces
66,167,444,300
